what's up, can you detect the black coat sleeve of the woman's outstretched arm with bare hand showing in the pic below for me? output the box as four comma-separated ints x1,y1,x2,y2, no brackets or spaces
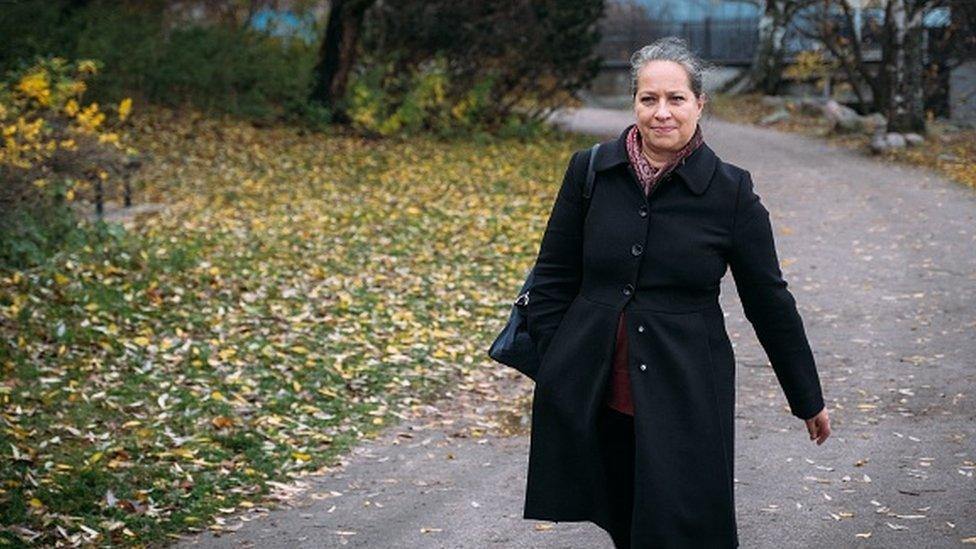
729,172,824,419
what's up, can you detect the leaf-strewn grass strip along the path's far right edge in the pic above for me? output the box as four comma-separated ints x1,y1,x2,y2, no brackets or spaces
711,94,976,189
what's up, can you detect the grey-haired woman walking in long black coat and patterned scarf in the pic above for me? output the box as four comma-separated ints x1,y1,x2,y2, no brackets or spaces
523,38,830,547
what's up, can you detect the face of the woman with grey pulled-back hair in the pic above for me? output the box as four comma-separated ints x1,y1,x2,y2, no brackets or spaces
634,61,705,152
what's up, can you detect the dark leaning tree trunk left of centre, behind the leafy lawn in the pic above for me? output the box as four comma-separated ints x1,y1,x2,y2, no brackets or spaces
310,0,374,123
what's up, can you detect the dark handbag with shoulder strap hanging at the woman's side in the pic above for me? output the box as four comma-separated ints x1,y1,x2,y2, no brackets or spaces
488,143,600,381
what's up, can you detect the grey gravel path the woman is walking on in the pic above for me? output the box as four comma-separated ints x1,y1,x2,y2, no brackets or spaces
180,109,976,548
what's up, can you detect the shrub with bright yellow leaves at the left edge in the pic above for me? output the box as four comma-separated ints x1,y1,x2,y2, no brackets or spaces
0,57,135,267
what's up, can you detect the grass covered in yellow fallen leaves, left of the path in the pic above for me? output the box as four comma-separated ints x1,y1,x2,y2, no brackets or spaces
0,105,590,545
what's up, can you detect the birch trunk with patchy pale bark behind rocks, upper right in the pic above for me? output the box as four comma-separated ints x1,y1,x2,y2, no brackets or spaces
884,0,925,133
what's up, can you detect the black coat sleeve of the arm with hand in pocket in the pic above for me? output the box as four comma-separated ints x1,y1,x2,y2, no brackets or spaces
526,151,586,360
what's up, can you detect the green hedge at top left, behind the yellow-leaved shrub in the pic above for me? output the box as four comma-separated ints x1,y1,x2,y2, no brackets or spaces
0,0,327,123
